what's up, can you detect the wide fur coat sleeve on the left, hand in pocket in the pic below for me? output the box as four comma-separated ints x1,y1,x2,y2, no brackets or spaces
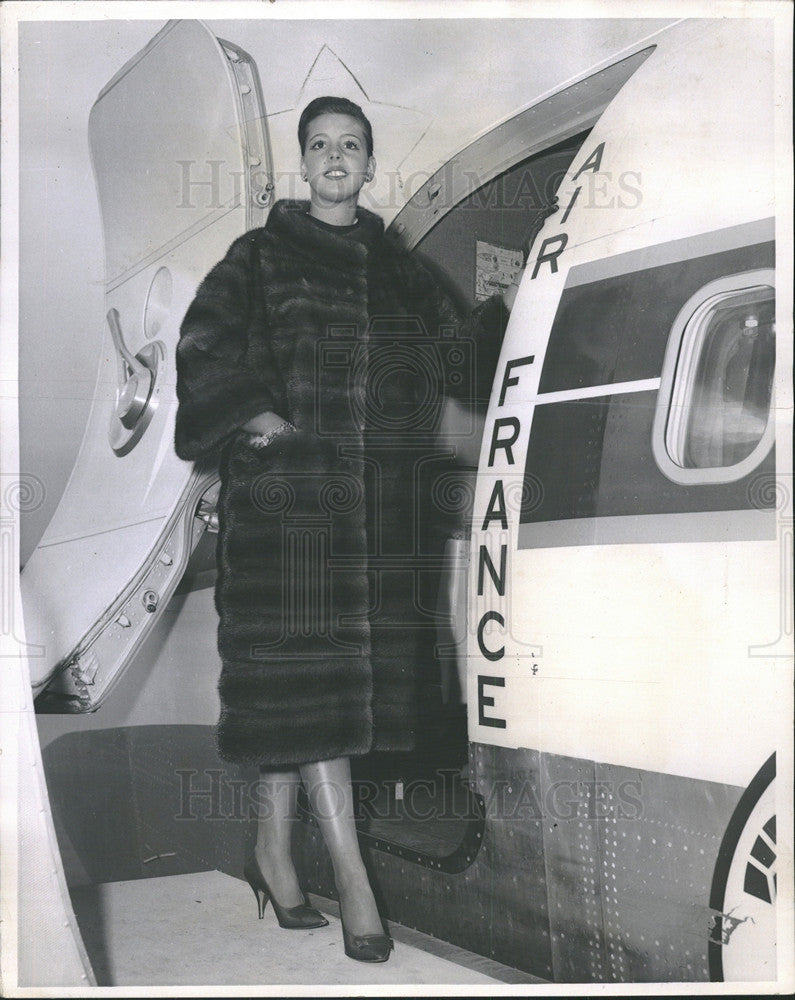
174,234,282,460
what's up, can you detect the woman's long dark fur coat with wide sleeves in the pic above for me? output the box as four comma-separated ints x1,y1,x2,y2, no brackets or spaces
175,201,506,767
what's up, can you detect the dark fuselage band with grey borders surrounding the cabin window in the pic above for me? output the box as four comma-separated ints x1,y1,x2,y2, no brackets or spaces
519,220,775,548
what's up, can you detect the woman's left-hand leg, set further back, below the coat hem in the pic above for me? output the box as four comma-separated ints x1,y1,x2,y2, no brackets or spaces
254,770,304,907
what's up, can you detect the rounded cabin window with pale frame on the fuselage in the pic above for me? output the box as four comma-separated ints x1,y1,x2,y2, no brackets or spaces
654,270,775,483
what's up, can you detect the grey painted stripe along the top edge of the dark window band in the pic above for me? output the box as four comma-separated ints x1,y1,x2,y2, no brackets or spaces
565,218,776,289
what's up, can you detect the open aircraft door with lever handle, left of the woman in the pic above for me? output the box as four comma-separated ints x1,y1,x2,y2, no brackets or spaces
21,21,273,711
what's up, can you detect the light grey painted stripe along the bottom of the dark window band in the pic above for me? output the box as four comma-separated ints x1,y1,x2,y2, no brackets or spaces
518,509,776,549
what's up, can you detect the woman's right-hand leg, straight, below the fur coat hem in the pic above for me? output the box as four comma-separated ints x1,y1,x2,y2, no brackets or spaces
301,757,384,935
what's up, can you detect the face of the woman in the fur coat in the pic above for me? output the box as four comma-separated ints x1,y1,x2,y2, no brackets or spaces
301,113,375,207
